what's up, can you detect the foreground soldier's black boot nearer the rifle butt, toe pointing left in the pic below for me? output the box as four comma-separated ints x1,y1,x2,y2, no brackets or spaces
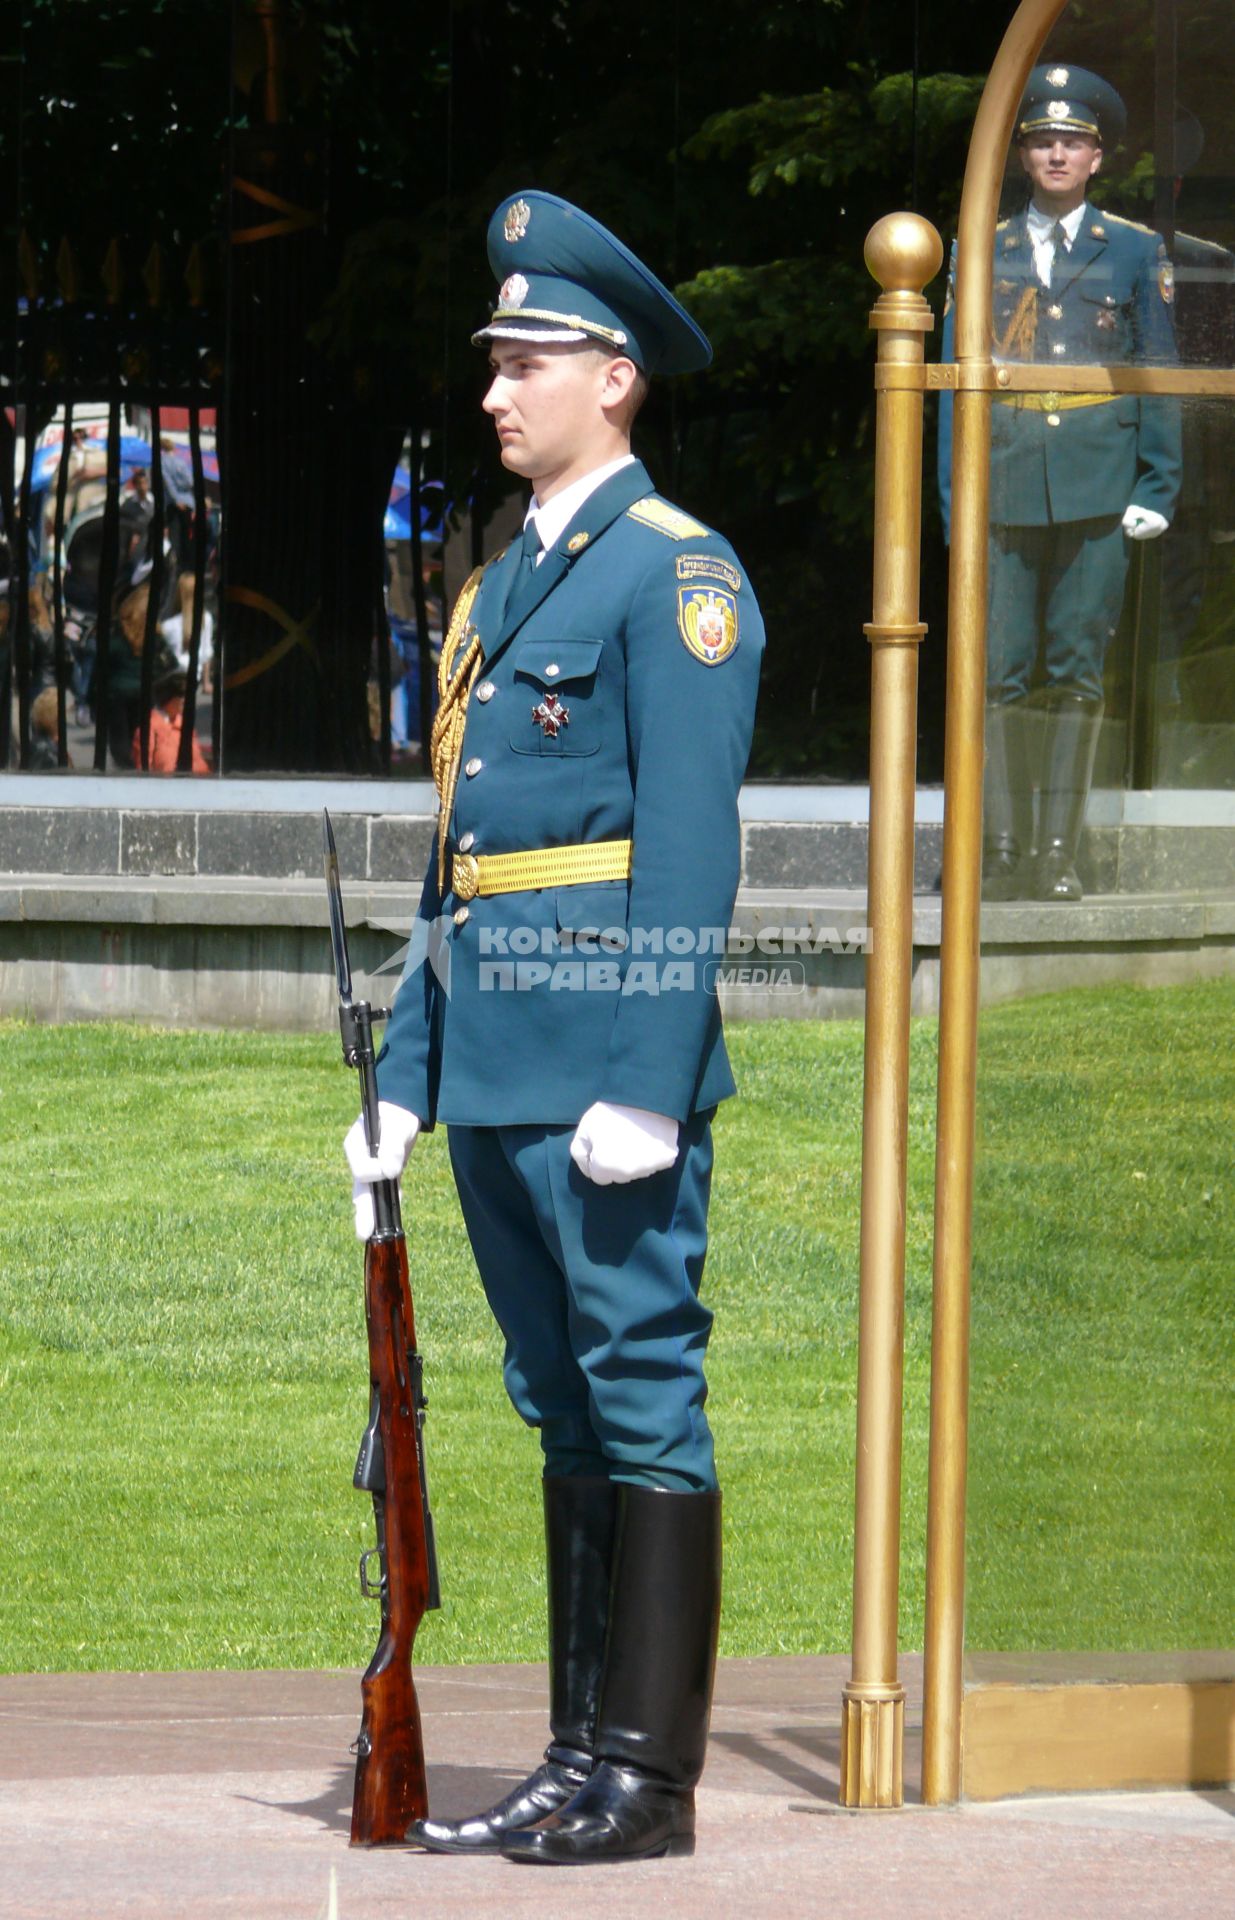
407,1475,618,1853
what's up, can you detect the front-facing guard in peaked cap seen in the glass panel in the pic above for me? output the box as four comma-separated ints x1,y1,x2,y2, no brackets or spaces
939,65,1181,900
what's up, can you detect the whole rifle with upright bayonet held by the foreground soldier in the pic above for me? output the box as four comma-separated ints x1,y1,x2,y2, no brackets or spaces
323,814,442,1847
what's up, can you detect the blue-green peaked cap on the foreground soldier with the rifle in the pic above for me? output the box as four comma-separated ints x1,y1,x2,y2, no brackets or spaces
472,186,713,374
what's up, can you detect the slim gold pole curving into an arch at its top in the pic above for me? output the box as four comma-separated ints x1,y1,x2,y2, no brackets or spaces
922,0,1066,1805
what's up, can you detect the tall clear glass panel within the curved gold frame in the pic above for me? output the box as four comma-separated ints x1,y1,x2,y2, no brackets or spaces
966,0,1235,1670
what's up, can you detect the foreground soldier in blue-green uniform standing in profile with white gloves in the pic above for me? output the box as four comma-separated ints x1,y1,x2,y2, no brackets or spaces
348,190,763,1864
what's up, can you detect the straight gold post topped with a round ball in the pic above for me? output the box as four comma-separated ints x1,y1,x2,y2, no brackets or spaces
841,213,943,1807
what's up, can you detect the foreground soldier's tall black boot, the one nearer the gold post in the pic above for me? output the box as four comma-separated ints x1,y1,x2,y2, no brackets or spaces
501,1486,720,1866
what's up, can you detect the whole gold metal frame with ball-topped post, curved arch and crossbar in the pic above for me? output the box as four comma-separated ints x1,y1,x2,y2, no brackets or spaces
841,0,1235,1807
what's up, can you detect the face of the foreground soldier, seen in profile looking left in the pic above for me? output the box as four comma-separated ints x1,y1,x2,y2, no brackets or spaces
484,340,607,501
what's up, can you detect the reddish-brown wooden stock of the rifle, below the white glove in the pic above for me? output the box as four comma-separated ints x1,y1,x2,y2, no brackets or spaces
351,1202,438,1847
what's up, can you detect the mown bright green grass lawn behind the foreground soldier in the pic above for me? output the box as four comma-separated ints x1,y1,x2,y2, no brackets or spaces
0,983,1235,1670
